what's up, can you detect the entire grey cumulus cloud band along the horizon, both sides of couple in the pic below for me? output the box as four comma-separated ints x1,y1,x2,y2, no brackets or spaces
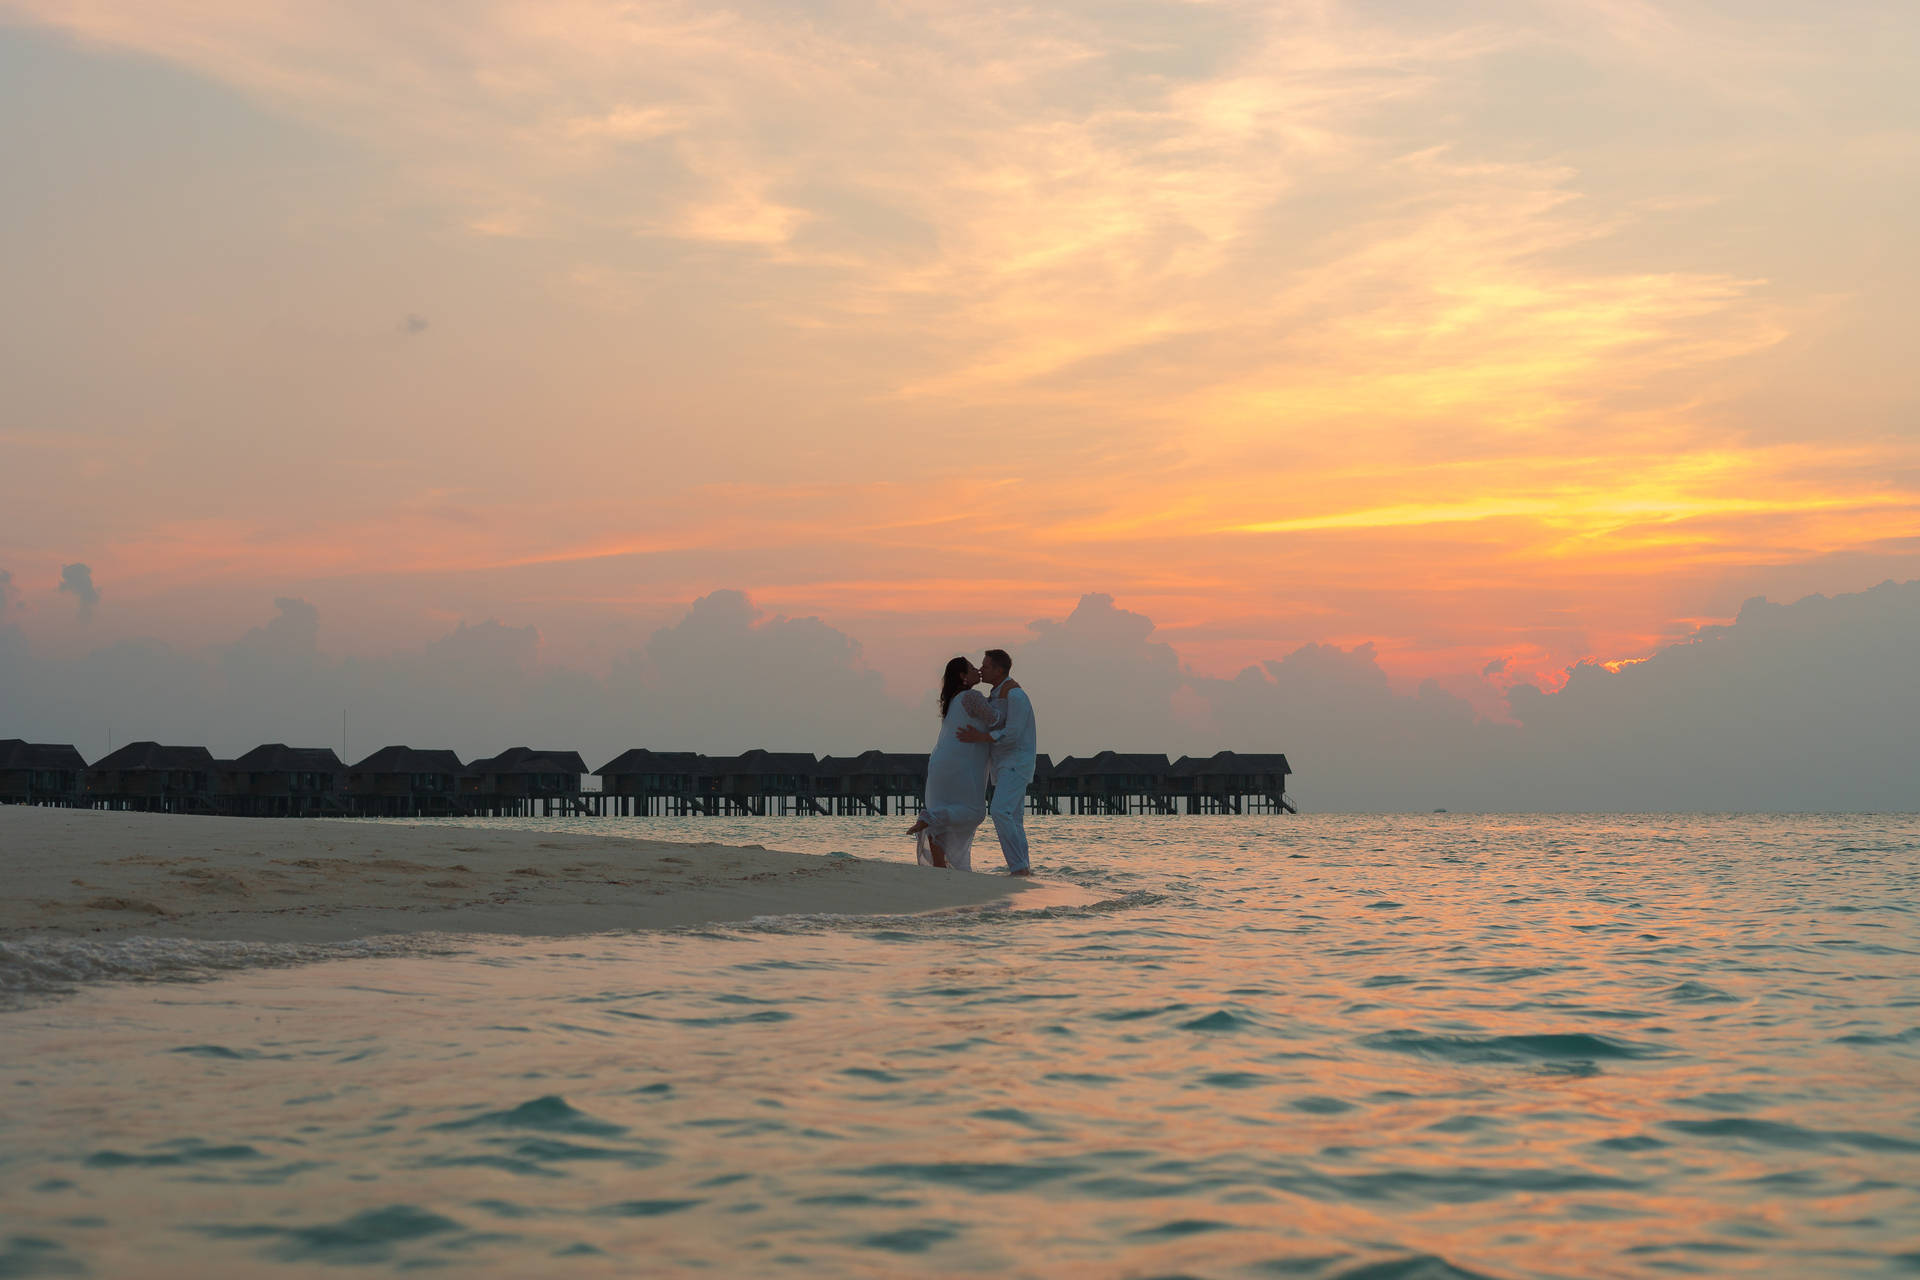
0,581,1920,812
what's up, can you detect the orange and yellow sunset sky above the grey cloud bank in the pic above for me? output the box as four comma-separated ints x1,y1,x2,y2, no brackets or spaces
0,0,1920,714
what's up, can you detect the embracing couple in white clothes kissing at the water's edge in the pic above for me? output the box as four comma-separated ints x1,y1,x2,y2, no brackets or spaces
908,649,1035,875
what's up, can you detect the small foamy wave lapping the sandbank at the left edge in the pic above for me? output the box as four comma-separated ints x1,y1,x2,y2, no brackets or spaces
0,935,459,1007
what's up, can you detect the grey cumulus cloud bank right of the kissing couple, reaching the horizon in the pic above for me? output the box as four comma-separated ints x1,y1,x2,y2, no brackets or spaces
1014,581,1920,812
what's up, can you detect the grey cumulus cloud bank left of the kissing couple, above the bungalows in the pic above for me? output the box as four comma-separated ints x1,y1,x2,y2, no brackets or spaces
0,591,910,764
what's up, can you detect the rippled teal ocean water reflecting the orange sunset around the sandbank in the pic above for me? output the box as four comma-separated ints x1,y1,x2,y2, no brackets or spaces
0,816,1920,1280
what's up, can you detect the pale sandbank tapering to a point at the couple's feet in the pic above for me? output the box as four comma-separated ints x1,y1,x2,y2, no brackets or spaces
0,806,1044,942
